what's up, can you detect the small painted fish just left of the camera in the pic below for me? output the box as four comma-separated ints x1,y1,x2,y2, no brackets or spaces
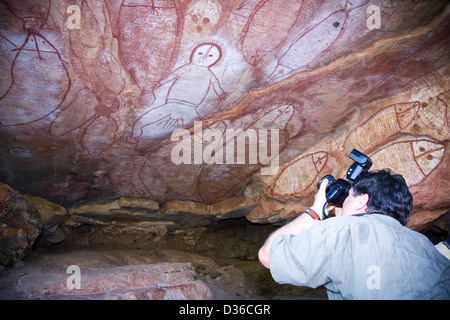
270,151,328,196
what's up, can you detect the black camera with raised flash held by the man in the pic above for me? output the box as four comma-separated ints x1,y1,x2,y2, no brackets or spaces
317,149,372,207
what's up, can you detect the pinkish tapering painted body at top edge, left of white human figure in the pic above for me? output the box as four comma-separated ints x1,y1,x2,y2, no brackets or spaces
117,0,184,103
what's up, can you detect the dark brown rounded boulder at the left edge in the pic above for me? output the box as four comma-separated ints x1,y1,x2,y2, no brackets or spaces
0,183,42,266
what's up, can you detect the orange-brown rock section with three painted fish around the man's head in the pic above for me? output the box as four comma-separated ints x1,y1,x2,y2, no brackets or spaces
253,63,449,228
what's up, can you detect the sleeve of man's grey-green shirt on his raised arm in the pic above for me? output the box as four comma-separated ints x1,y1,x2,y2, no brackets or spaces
269,221,337,288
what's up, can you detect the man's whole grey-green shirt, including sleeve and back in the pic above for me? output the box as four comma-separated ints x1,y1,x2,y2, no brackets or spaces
270,214,450,299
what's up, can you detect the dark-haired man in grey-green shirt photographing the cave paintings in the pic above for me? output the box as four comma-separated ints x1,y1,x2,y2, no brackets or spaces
259,170,450,299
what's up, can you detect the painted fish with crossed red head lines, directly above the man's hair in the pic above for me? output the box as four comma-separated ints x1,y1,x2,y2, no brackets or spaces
369,137,445,187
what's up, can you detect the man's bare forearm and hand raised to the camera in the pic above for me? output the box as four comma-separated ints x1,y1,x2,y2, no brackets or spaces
258,180,328,269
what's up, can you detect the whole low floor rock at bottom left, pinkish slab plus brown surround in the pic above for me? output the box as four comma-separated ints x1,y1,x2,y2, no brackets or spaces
0,250,264,300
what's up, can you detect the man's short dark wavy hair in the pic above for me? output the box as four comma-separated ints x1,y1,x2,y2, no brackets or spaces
352,169,413,225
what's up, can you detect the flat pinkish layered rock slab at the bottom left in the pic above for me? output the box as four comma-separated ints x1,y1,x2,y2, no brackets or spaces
1,263,213,300
